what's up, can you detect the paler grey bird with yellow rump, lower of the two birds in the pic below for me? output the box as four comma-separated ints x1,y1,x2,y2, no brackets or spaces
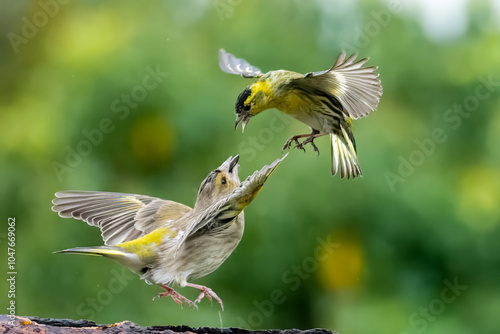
52,155,286,308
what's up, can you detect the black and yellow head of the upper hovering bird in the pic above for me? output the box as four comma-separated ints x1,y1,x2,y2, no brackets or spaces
234,80,272,131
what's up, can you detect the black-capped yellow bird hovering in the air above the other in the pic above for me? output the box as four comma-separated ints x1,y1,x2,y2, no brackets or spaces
219,49,382,178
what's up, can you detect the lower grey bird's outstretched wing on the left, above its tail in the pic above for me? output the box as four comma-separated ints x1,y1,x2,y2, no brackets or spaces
52,191,191,245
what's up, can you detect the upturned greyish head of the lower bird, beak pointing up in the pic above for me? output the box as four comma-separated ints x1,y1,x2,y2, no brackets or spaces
195,155,240,206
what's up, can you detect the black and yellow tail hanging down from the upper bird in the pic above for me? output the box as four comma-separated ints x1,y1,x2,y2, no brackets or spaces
330,125,362,179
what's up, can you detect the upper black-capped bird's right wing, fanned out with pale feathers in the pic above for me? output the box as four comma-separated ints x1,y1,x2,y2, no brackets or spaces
295,51,382,118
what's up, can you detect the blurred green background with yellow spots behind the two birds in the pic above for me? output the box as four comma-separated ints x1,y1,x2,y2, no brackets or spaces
0,0,500,334
